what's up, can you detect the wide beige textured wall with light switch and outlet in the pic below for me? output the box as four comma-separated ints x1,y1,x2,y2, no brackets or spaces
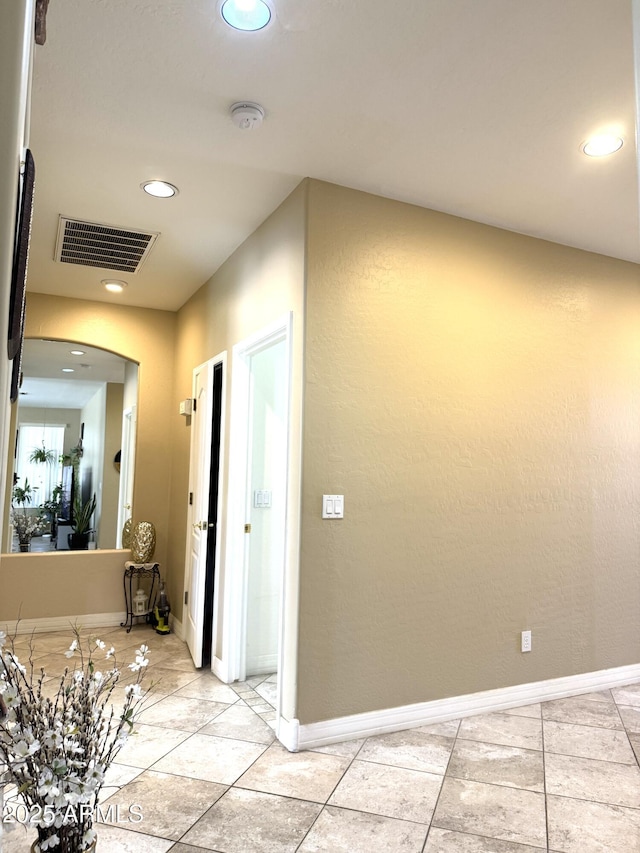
298,181,640,723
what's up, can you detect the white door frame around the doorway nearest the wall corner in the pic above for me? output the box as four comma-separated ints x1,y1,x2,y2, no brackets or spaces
220,312,299,720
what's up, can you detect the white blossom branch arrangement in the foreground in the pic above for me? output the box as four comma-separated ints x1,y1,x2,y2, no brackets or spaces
0,627,149,853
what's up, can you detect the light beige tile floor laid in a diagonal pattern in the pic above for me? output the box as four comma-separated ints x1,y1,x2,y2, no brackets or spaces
3,626,640,853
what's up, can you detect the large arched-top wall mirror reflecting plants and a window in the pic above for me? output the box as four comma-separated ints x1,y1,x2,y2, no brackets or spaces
2,339,138,552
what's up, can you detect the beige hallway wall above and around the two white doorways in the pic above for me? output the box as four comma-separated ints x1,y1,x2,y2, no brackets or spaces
169,183,306,643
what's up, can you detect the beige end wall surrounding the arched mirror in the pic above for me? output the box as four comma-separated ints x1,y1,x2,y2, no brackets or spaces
0,293,175,619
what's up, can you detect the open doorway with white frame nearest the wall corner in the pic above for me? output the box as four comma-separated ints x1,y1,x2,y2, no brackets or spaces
220,317,291,716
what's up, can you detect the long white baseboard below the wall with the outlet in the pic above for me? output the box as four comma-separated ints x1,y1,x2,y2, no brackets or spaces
288,664,640,752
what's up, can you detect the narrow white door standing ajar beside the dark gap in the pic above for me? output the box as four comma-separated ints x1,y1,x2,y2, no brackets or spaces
183,360,214,666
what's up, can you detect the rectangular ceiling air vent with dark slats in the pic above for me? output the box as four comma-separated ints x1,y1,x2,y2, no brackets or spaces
55,216,159,274
